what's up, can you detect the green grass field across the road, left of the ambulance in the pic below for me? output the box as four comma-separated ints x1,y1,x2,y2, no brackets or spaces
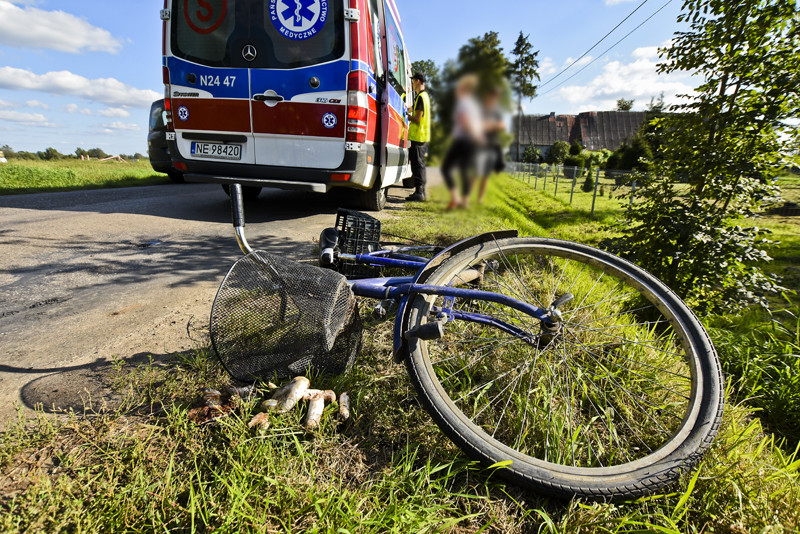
0,159,169,195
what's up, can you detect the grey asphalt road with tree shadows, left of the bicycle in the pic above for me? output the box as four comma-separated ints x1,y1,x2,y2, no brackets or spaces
0,184,416,426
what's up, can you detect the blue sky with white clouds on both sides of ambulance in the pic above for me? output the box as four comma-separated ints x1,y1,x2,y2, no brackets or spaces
0,0,696,154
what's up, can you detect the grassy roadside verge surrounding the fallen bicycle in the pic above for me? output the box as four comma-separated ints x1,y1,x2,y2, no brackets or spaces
0,174,800,533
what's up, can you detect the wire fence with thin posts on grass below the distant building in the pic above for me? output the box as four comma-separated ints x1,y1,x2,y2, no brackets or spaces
507,162,637,215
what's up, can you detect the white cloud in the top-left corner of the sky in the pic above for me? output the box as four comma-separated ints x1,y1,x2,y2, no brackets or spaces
0,0,122,54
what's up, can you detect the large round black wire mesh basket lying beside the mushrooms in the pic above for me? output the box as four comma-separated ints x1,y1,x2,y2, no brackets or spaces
210,250,362,382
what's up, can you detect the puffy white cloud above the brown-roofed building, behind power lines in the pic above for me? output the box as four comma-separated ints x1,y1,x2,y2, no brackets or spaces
558,47,693,113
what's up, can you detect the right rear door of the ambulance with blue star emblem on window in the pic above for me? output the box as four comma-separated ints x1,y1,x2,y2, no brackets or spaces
250,0,350,169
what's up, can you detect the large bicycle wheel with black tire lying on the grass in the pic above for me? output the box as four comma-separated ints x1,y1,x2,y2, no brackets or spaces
404,238,724,499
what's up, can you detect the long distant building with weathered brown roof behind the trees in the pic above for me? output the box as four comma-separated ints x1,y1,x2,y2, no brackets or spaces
511,111,647,158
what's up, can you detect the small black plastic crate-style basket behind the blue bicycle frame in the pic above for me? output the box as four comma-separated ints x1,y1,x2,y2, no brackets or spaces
336,208,381,279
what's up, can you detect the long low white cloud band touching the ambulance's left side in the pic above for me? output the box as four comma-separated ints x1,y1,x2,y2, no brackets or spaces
0,67,162,108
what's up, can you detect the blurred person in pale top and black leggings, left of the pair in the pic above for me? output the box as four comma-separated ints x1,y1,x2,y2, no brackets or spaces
442,74,484,210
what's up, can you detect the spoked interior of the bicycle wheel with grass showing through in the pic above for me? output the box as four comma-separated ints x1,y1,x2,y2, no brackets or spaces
406,241,720,480
